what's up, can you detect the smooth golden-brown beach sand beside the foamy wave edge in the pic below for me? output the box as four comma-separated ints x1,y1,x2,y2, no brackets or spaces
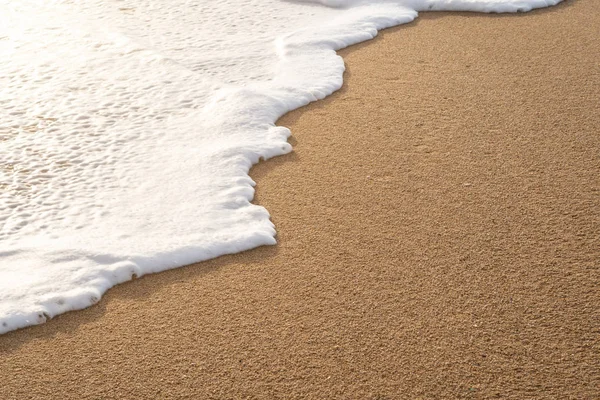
0,0,600,399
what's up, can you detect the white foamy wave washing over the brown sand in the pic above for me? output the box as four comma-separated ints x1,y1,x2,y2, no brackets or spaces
0,0,560,333
